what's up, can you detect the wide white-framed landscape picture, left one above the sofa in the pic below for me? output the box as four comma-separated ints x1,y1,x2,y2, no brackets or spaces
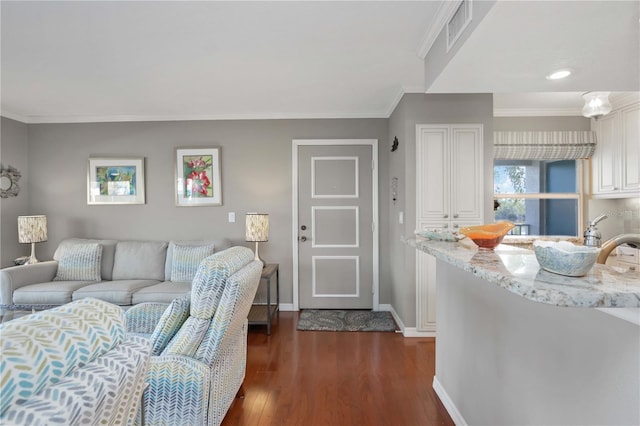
87,157,145,205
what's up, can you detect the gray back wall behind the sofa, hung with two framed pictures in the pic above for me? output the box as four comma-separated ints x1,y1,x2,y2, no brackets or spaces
2,119,390,303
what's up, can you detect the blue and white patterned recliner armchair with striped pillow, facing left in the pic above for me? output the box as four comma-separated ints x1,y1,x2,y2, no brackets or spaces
126,247,262,425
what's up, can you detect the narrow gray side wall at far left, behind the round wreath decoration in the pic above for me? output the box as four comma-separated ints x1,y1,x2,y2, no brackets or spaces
0,117,30,268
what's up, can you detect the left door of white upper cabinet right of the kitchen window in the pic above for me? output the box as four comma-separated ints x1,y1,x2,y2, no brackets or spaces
591,111,620,194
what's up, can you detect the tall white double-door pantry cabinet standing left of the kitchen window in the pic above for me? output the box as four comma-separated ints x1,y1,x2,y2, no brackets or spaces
416,124,484,335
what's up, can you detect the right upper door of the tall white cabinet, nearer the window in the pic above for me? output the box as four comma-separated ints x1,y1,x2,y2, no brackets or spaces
450,126,484,220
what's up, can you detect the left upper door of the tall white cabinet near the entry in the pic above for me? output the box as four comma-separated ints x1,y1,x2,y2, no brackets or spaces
416,126,450,221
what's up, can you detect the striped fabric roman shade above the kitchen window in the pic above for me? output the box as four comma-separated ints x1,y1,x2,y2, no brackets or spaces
493,131,596,160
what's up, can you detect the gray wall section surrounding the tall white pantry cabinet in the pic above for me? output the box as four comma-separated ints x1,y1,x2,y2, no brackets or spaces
381,94,493,327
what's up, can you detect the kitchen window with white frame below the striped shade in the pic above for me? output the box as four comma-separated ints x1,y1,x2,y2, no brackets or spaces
493,160,582,236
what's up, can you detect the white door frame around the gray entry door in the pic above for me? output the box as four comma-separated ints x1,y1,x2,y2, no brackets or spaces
291,139,380,311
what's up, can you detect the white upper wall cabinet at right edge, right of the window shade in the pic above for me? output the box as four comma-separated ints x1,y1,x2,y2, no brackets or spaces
591,103,640,198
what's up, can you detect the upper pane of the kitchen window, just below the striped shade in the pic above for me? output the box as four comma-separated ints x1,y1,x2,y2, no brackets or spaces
493,160,577,194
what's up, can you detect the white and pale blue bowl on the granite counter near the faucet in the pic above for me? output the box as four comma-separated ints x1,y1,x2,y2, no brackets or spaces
533,240,600,277
